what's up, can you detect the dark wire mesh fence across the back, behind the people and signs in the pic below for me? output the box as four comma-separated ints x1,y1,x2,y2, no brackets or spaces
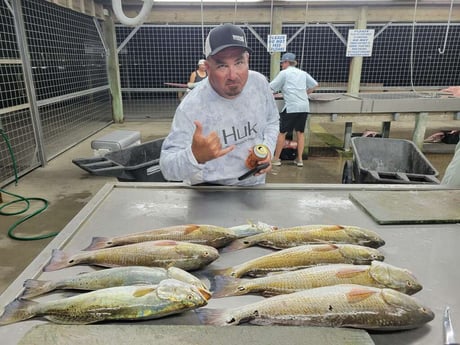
117,23,460,118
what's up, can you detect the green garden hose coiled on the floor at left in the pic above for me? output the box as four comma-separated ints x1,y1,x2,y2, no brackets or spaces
0,128,58,241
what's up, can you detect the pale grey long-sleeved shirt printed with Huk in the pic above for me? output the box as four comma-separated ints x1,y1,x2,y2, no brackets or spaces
160,71,279,186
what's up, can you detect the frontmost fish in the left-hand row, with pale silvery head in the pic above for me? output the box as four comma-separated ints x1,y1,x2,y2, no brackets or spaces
0,279,211,325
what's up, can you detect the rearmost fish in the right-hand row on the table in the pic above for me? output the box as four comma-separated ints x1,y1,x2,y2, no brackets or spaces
223,225,385,252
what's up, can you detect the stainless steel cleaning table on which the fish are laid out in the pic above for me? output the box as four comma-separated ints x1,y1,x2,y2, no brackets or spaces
0,182,460,345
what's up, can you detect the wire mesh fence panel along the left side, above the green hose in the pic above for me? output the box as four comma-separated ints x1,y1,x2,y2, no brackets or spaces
0,0,112,184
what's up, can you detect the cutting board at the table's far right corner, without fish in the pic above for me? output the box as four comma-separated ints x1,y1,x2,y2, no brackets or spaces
349,190,460,224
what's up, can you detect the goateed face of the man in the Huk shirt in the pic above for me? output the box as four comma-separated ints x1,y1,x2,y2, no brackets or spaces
206,47,249,99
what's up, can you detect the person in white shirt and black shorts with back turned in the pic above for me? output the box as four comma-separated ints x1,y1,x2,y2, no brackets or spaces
270,53,318,167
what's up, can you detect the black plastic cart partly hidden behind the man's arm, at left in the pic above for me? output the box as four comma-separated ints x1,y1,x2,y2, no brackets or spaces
72,138,166,182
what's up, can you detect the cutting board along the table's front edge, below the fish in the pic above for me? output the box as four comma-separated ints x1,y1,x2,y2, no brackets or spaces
20,323,374,345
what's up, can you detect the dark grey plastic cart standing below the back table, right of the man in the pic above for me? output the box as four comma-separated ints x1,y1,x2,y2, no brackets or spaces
342,137,440,184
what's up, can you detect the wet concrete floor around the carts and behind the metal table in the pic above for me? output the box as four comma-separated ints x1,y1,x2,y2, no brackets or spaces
0,120,459,293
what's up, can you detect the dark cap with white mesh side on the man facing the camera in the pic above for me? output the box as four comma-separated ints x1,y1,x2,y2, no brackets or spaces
204,23,252,57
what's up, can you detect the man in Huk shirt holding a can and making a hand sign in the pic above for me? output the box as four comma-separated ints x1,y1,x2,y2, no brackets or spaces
160,24,279,186
